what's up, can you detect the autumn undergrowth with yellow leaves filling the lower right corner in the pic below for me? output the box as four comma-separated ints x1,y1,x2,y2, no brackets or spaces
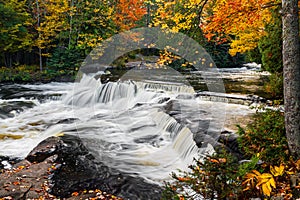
162,106,300,199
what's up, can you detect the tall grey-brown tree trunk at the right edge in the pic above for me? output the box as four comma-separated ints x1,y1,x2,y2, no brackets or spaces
282,0,300,159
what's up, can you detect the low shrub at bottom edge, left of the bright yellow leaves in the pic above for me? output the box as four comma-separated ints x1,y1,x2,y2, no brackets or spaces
162,150,258,200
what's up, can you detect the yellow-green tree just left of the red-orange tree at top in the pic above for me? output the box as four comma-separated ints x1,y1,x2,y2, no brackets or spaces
70,0,116,51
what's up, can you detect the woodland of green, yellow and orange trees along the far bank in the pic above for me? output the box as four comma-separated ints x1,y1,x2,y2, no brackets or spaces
0,0,296,76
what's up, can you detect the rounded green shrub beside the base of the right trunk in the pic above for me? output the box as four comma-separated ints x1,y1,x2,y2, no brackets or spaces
238,109,290,165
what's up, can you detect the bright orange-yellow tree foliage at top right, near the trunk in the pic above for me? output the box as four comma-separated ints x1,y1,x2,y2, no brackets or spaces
201,0,279,55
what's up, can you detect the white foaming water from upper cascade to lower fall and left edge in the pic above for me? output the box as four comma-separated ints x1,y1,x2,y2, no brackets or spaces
0,75,216,183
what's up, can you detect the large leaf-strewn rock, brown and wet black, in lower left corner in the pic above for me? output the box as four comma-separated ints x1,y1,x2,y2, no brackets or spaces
0,135,162,199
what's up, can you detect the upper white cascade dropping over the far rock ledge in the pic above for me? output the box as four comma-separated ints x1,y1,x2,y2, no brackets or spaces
64,75,194,106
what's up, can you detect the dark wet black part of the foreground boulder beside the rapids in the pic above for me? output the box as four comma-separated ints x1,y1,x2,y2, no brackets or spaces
26,135,162,199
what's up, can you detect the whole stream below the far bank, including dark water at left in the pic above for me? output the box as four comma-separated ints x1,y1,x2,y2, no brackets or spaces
0,65,262,183
